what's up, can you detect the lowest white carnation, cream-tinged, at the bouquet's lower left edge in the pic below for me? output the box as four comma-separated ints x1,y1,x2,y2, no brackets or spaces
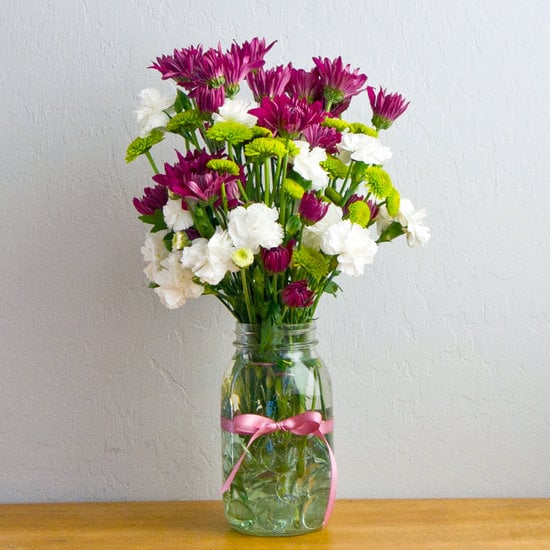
154,252,204,309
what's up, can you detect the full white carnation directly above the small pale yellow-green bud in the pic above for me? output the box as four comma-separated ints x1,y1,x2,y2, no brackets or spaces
227,203,284,254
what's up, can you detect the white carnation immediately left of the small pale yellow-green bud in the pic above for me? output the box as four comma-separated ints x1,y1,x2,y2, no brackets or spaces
181,231,239,285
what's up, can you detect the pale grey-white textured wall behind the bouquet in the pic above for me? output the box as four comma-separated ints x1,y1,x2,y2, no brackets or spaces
0,0,550,502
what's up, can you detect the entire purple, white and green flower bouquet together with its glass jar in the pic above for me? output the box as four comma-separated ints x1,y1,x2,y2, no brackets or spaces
126,38,430,535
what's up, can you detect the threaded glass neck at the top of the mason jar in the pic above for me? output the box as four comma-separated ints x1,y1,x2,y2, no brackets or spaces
233,321,317,350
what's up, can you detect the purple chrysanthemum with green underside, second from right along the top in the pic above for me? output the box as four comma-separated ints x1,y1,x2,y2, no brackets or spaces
313,57,367,114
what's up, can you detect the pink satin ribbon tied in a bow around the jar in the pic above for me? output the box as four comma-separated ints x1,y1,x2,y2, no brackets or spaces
221,411,338,527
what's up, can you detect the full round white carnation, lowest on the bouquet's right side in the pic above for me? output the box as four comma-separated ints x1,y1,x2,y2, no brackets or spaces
321,220,378,277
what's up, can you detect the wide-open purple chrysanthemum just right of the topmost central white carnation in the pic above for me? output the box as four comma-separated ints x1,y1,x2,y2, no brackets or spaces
248,95,326,137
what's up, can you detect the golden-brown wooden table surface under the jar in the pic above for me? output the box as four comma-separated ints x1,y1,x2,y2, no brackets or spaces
0,499,550,550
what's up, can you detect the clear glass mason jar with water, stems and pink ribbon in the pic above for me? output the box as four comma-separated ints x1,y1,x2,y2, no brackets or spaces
221,323,336,536
